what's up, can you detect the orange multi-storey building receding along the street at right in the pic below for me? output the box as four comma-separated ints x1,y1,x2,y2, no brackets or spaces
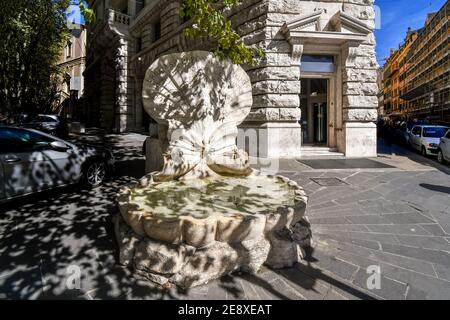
384,1,450,122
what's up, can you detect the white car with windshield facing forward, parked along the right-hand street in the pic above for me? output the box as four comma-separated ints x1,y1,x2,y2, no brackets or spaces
409,125,449,156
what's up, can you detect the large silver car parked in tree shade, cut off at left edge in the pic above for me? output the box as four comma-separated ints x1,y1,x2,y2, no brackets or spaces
0,126,114,202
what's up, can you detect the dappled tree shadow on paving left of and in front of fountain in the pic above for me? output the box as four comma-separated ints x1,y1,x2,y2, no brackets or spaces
0,131,380,299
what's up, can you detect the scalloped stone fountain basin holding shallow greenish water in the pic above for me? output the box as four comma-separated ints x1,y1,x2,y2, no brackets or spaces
118,173,307,248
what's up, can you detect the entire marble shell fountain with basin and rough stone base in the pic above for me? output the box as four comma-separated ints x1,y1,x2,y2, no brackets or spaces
114,51,311,288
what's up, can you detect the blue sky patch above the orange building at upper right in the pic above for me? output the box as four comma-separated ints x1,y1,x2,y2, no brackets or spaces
375,0,446,66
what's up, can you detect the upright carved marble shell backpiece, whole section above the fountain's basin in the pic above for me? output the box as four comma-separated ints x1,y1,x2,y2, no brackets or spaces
143,51,253,181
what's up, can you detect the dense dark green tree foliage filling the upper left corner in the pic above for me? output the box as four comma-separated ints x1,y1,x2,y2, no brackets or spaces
0,0,70,113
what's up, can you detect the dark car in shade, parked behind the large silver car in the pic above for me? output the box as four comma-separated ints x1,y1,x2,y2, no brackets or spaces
17,114,69,139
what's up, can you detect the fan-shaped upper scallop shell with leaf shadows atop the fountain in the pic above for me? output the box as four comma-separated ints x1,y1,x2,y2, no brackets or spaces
143,51,253,128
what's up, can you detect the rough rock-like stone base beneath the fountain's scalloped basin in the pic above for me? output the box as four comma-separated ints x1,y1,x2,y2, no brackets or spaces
114,214,311,288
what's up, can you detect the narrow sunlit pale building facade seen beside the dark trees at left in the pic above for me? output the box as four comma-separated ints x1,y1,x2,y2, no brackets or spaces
58,23,87,117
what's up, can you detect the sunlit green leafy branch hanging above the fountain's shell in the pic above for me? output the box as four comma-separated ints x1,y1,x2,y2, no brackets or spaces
180,0,264,65
